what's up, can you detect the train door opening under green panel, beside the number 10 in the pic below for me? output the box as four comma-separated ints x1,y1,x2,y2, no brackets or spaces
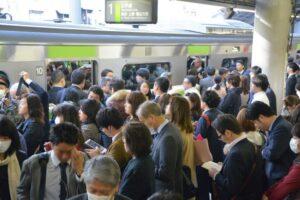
47,60,97,90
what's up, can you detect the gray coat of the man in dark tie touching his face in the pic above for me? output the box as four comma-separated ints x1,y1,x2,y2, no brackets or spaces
17,153,86,200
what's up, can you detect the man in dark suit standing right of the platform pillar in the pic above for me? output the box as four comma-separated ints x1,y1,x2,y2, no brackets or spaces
285,62,299,96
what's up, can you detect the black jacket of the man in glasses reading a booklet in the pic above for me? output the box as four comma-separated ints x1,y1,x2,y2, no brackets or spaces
215,139,264,200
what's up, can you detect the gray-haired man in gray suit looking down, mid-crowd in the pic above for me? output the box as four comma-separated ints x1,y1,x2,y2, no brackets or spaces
137,101,182,194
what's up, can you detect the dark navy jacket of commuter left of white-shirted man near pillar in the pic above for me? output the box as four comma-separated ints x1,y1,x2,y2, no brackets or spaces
218,88,242,116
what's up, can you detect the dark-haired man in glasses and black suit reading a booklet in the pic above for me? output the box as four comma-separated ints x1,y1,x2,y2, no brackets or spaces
208,114,264,200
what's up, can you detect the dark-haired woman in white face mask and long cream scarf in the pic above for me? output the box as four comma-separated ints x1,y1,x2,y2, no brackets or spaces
0,115,26,200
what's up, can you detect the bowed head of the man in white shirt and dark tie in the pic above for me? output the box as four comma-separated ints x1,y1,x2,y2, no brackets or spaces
49,122,80,163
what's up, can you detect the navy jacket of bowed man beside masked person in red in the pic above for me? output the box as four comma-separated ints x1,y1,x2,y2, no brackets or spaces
262,116,295,186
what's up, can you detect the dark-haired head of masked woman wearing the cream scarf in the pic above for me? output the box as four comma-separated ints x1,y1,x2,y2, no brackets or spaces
0,115,20,156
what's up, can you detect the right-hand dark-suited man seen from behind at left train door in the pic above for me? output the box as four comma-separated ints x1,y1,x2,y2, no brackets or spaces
60,69,87,105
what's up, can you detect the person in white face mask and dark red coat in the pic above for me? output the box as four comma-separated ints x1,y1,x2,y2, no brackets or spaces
264,123,300,200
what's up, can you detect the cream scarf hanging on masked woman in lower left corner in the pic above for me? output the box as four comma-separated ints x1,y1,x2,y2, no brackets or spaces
0,153,21,200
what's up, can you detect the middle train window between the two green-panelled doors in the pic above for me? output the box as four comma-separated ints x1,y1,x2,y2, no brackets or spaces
122,62,171,90
